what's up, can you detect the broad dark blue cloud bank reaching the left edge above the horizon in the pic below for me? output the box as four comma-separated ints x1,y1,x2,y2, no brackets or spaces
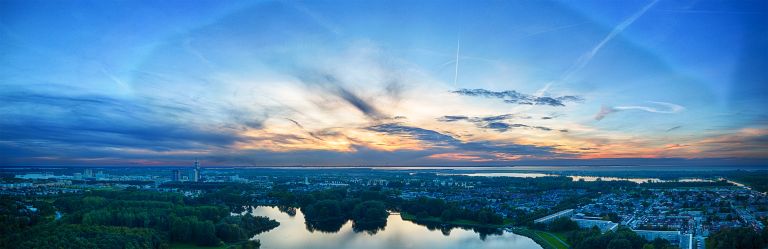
0,91,246,151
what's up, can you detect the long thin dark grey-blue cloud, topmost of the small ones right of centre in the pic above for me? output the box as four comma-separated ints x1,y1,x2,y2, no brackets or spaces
453,88,584,106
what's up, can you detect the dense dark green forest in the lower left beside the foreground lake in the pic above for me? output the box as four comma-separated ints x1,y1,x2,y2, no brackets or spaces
0,191,279,248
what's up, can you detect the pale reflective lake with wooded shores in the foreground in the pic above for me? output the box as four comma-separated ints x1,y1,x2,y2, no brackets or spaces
253,207,541,249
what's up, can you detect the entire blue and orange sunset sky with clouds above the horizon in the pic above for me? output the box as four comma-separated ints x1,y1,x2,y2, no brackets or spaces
0,0,768,166
